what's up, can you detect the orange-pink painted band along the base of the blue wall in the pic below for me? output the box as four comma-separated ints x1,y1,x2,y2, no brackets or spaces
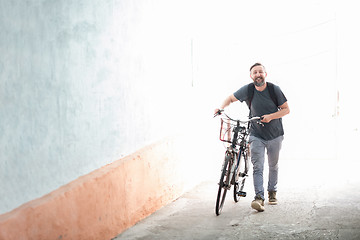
0,139,184,240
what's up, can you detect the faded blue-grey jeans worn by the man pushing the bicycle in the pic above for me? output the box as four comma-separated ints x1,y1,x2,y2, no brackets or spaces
249,136,284,200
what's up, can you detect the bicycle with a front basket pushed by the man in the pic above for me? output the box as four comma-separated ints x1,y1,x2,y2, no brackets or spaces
214,110,263,216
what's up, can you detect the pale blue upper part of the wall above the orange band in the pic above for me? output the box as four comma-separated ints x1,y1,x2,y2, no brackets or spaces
0,0,197,214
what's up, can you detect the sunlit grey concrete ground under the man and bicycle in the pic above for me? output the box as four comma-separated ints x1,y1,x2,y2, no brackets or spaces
114,160,360,240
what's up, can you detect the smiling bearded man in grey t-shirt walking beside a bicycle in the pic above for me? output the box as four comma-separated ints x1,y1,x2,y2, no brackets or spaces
215,63,290,212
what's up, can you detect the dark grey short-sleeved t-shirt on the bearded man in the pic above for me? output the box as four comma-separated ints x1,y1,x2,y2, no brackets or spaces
234,85,287,140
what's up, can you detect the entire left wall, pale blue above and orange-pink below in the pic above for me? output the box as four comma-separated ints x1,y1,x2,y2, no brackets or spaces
0,0,215,240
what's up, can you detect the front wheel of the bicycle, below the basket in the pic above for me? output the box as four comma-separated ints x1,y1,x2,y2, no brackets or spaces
215,154,231,216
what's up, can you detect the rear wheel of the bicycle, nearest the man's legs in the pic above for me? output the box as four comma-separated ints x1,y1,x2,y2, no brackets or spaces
233,152,248,202
